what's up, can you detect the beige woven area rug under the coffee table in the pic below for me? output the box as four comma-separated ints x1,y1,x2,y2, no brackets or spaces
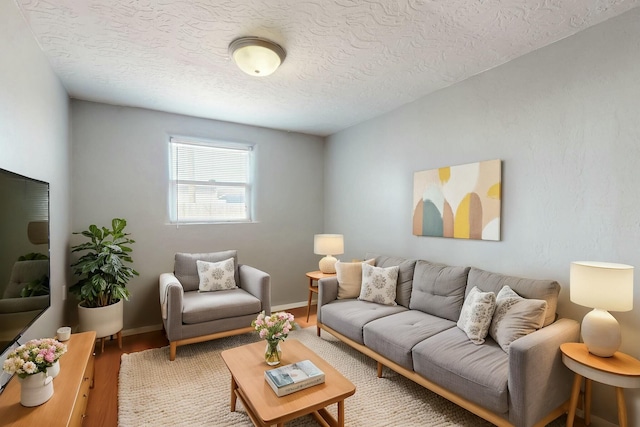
118,327,564,427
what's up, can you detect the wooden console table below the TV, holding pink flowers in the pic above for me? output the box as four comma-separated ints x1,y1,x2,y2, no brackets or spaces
0,331,96,426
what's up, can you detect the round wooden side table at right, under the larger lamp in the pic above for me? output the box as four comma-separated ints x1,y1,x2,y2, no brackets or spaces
560,343,640,427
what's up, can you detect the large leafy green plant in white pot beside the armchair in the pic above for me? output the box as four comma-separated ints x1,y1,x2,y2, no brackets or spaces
69,218,138,338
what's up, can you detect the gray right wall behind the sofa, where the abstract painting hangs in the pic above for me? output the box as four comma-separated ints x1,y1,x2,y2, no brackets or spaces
325,9,640,425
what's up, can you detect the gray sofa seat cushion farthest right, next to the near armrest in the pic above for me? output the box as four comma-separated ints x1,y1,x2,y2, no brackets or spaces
412,328,509,414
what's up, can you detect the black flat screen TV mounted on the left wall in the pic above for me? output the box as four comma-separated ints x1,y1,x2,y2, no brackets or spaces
0,169,50,358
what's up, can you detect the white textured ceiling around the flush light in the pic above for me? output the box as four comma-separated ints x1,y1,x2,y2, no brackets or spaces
14,0,640,135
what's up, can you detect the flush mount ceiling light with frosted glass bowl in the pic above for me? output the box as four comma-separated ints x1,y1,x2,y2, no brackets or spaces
229,37,287,77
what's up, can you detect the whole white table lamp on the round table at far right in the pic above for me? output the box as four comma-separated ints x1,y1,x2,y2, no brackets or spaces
569,261,633,357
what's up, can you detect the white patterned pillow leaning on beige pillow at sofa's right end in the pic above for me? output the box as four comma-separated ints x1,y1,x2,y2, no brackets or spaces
457,286,496,345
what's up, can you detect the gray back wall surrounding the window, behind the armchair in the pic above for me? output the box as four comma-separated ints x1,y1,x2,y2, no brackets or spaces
71,100,324,329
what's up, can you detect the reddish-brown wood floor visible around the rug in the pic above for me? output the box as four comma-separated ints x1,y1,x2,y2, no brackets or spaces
83,305,316,427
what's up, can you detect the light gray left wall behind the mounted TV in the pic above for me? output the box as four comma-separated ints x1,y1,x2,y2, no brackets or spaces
0,1,70,350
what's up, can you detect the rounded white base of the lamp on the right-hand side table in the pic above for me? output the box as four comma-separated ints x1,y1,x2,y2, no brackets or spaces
582,308,622,357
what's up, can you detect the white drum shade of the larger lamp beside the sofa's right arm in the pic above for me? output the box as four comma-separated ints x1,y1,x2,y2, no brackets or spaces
569,261,633,311
